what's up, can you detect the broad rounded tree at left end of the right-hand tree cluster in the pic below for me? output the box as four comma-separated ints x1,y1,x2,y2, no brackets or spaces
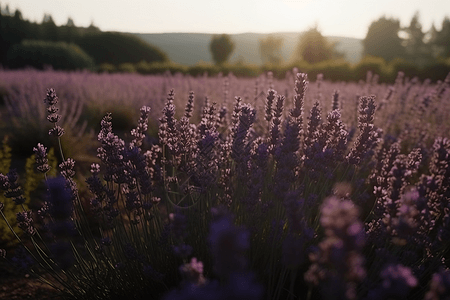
363,17,405,62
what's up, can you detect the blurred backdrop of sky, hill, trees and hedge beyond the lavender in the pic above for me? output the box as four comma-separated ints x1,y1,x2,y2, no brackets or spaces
0,0,450,81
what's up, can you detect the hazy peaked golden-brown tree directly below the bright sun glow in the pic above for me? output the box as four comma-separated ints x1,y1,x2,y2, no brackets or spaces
294,25,334,64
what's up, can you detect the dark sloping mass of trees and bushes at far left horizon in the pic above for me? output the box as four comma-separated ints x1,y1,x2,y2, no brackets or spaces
0,5,169,70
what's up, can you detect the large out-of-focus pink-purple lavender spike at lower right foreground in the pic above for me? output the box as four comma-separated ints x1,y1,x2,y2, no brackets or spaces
305,196,366,299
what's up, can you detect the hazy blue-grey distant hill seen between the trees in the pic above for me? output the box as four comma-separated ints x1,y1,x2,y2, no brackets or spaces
136,32,363,65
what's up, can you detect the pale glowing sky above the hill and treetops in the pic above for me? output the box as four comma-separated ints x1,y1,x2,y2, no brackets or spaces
0,0,450,39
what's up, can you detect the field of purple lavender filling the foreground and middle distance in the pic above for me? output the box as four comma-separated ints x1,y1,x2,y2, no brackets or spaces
0,69,450,300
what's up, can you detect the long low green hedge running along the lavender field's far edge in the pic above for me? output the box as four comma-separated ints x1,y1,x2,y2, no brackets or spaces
97,57,450,83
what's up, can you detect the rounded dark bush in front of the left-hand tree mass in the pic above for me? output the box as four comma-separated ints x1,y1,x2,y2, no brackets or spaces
7,40,94,70
